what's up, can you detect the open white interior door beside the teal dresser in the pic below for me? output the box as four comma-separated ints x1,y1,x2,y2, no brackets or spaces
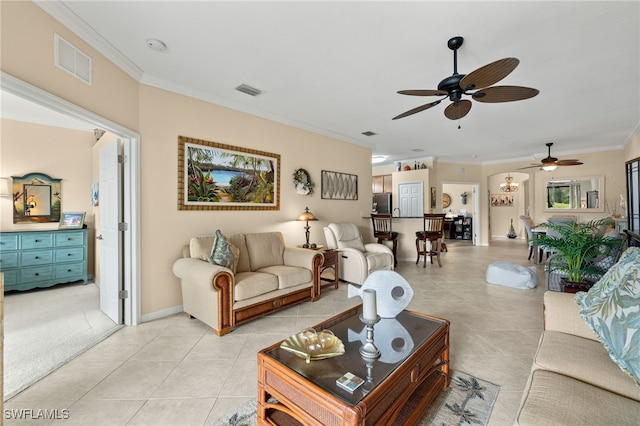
97,139,123,324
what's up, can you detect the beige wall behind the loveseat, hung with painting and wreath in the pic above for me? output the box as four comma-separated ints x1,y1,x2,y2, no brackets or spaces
140,85,371,313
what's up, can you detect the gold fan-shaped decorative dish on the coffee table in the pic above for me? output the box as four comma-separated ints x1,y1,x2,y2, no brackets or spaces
280,328,344,363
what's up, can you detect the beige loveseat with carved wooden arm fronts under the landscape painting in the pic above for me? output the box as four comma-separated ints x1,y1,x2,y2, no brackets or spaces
173,232,323,336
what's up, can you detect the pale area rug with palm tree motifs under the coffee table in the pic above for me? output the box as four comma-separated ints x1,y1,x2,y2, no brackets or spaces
210,371,500,426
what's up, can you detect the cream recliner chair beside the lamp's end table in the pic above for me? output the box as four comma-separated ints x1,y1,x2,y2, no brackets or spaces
324,223,394,284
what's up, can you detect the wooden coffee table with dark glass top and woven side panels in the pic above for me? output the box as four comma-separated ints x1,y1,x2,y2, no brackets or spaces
258,306,449,426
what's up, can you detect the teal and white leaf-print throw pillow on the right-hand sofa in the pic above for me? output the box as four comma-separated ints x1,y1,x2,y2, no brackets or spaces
576,247,640,386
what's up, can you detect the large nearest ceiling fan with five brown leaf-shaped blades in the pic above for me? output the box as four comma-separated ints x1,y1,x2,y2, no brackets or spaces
393,37,540,120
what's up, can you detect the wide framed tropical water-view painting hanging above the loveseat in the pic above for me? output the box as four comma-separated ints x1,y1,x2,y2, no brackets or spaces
178,136,280,210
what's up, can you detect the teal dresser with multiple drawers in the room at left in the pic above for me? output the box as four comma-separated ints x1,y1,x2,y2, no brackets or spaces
0,229,89,292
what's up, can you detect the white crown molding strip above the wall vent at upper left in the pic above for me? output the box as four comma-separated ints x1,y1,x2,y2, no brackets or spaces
33,0,144,81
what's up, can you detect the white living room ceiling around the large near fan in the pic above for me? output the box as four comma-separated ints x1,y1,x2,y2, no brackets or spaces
11,1,640,164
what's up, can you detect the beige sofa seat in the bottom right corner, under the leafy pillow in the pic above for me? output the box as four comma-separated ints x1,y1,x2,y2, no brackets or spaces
516,291,640,426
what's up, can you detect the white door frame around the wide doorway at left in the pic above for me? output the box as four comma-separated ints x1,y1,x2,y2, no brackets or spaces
0,71,142,325
